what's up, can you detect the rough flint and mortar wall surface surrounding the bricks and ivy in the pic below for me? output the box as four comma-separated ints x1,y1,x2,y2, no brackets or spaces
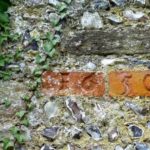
0,0,150,150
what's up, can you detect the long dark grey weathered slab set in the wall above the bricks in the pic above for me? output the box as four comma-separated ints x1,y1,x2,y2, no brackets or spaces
62,27,150,55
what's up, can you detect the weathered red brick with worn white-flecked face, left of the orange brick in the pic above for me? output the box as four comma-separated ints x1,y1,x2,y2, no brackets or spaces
42,71,105,97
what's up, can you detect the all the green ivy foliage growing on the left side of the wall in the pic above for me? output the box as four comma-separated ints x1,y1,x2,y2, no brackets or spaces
0,0,71,150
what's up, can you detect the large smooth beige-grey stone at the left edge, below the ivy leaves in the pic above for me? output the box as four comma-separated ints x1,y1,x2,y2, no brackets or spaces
0,81,29,119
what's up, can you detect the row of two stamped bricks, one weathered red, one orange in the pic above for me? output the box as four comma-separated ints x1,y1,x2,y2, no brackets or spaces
41,71,150,97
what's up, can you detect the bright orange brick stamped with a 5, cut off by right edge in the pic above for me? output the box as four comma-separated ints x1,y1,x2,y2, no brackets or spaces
109,71,150,97
